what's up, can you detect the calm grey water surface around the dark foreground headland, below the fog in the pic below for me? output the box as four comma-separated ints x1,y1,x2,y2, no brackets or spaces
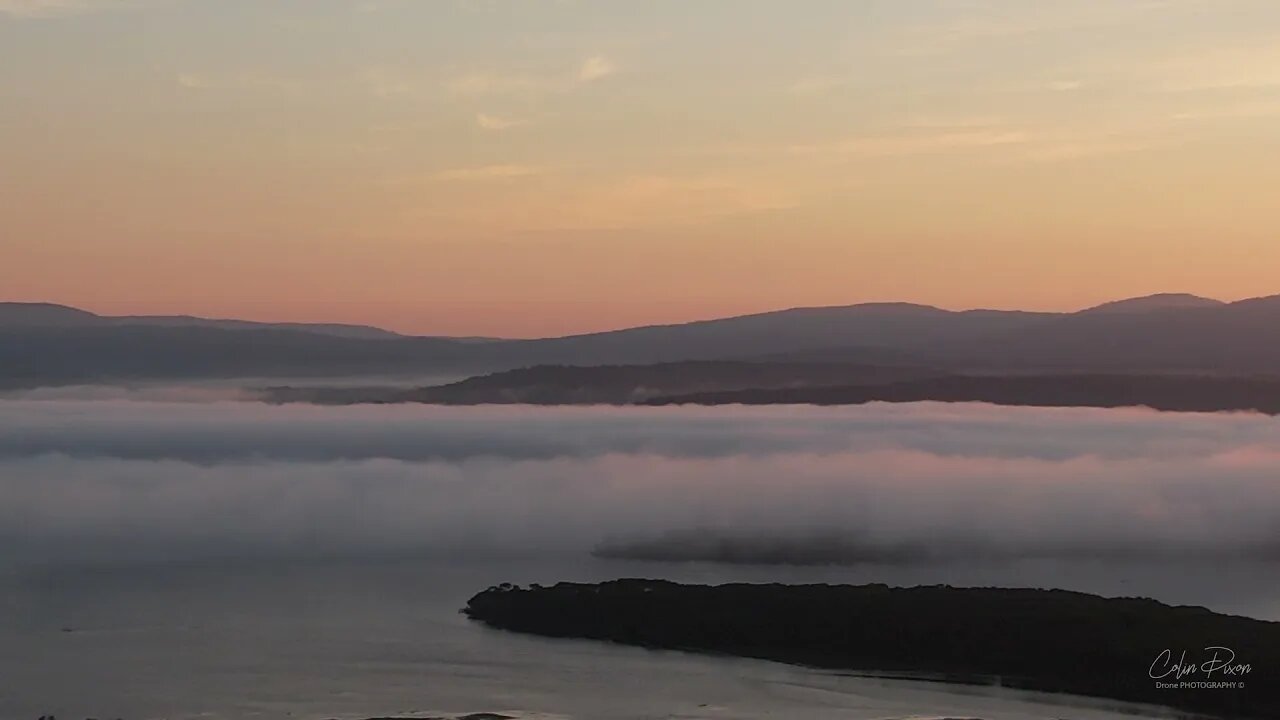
0,550,1280,720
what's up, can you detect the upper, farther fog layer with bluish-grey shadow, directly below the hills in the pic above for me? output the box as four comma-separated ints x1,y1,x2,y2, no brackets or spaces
0,400,1264,465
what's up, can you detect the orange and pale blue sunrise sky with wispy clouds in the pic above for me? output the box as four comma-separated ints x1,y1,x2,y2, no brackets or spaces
0,0,1280,337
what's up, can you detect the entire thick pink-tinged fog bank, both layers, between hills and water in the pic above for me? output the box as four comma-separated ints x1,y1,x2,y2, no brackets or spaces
0,394,1280,564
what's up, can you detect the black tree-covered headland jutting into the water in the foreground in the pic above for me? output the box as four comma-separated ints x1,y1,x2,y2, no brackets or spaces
463,579,1280,720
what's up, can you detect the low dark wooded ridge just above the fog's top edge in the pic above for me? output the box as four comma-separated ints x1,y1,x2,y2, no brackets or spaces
257,363,1280,415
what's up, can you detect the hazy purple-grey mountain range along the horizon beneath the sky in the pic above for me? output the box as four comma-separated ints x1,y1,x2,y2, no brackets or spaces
0,295,1280,391
